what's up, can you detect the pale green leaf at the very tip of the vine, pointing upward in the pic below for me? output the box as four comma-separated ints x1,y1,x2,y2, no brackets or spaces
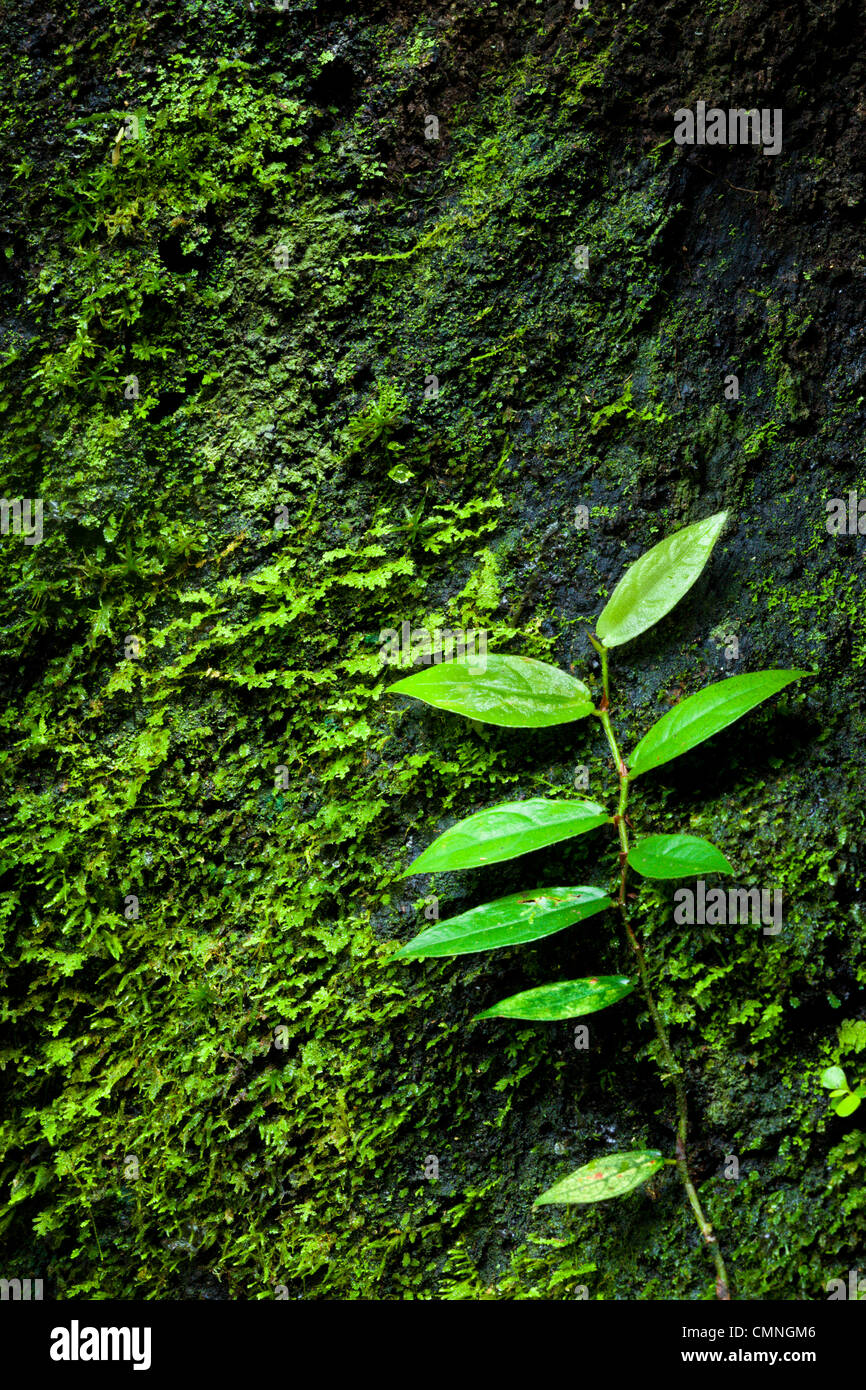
596,512,727,646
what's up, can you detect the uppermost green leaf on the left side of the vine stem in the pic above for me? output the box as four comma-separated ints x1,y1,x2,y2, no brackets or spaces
388,652,594,728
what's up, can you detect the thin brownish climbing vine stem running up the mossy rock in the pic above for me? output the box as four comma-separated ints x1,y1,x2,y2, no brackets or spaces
589,635,731,1300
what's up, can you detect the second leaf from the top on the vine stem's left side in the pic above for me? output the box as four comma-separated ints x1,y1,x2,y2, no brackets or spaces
400,796,612,878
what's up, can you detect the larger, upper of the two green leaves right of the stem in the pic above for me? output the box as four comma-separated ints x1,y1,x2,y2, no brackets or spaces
628,671,809,777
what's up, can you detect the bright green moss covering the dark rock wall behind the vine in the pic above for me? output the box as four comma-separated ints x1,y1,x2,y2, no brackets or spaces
0,3,866,1298
